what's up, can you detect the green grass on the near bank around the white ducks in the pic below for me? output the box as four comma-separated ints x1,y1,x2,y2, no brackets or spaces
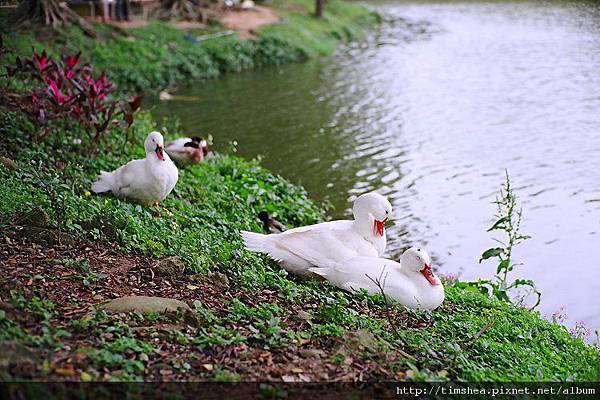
0,110,599,381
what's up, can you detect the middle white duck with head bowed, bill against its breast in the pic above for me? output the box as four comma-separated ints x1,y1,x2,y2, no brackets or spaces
242,193,392,274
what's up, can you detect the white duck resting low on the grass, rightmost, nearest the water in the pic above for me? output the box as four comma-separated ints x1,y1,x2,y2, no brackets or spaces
310,247,444,310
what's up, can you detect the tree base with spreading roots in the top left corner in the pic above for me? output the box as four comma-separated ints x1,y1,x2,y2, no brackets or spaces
15,0,96,37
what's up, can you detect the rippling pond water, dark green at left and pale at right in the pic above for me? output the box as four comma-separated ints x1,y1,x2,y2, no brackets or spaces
156,1,600,329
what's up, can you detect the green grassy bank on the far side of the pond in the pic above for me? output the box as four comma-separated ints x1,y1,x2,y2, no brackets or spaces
0,0,378,92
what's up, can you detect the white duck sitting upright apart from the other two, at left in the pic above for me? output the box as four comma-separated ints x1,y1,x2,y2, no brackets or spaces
92,132,179,204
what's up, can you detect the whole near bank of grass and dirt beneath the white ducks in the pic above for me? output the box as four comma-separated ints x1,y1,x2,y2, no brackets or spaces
0,108,598,381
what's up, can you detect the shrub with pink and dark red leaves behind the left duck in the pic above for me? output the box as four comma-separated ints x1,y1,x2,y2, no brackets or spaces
7,50,141,148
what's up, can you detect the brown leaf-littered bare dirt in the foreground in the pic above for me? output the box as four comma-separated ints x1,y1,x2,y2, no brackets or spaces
0,225,412,382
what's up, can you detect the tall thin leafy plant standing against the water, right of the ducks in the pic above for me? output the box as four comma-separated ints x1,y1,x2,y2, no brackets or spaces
466,172,542,309
